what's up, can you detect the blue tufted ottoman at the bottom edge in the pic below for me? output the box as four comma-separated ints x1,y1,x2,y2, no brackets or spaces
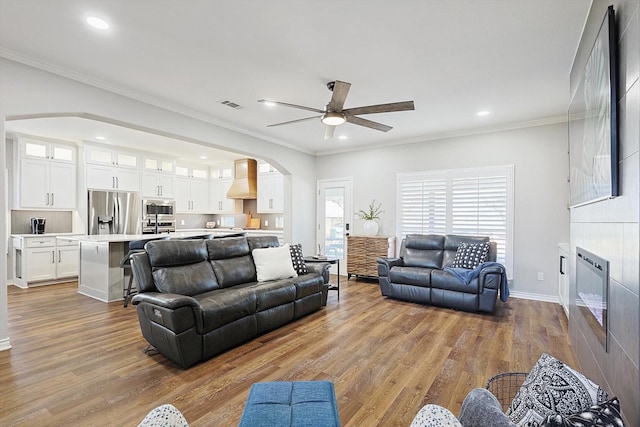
240,381,340,427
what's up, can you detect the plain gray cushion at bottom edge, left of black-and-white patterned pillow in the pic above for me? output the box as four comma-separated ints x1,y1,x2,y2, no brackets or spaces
458,388,515,427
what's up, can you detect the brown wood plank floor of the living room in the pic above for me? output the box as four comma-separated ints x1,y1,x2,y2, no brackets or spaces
0,278,579,427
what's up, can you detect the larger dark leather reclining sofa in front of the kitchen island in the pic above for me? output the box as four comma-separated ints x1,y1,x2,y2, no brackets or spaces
131,236,329,368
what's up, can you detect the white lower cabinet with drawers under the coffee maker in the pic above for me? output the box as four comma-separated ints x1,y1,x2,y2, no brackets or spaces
12,235,79,288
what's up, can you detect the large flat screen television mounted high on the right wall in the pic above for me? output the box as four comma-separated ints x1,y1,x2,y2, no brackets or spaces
568,6,618,208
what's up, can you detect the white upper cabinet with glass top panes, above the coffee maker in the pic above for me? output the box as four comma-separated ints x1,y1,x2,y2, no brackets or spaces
14,138,77,209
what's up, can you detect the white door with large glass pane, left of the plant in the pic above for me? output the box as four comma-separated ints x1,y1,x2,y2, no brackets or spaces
316,178,353,274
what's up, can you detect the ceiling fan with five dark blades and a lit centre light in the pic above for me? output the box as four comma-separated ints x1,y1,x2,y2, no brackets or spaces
258,80,414,139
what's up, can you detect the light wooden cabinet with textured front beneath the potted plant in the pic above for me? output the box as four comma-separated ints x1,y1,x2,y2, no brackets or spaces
347,236,396,280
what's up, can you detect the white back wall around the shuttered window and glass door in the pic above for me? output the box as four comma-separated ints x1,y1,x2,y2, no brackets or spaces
316,123,569,300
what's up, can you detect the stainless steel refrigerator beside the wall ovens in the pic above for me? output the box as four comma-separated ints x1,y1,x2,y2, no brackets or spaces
88,190,142,234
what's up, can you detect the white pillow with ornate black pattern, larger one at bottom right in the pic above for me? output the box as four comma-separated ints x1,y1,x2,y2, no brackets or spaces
507,353,607,427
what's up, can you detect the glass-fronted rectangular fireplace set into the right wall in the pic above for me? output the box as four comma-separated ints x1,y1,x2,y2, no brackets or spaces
576,247,609,351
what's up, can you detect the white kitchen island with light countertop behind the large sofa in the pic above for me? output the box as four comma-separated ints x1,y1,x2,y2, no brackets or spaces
70,229,282,302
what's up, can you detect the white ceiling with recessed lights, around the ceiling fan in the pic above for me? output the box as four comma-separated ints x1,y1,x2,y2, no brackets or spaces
0,0,591,160
